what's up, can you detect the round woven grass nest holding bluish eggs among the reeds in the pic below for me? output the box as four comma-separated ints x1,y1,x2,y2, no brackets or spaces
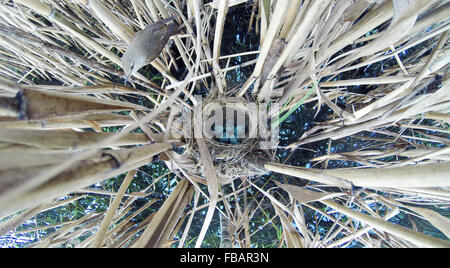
169,94,273,184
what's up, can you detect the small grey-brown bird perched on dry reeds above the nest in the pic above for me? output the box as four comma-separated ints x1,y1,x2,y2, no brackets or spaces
122,17,179,84
